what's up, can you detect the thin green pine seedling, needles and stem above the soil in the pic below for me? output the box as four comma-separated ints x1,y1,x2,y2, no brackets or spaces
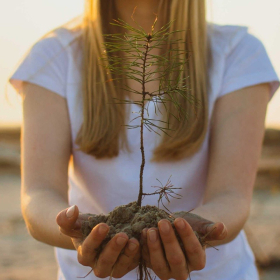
100,14,195,208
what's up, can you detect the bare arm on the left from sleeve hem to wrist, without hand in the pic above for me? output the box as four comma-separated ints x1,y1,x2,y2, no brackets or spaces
21,83,74,249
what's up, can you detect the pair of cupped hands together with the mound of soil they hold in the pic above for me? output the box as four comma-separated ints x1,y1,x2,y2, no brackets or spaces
57,203,226,279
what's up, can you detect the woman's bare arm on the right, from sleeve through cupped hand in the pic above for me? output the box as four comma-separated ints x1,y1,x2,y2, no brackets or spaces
143,84,270,279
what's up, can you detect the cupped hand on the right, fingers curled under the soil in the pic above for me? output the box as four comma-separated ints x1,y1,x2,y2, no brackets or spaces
142,216,226,279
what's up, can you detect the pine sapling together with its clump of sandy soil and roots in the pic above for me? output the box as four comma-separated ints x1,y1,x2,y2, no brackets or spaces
82,13,207,280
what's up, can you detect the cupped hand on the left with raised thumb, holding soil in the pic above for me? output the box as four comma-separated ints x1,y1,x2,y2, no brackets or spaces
56,205,140,278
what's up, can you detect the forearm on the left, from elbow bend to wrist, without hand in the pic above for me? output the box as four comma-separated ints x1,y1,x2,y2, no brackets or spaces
21,188,74,250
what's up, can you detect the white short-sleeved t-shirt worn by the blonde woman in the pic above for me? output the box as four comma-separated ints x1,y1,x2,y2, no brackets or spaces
10,14,279,280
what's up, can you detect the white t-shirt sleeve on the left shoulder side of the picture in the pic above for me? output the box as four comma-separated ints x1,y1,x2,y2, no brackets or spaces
9,36,67,98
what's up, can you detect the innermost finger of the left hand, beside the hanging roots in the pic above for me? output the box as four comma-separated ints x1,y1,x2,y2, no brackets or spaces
112,238,140,278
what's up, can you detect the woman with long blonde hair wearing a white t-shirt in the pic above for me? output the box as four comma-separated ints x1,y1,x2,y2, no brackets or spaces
7,0,279,280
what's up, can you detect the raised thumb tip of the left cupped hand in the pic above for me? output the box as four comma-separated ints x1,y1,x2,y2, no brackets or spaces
56,205,79,231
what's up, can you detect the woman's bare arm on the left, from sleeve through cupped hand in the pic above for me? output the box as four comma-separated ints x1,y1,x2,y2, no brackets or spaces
21,83,140,277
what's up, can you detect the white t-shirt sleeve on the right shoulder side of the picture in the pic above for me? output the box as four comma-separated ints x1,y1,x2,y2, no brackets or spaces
219,33,280,99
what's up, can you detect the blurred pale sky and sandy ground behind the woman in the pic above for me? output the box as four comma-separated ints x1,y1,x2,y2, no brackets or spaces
0,0,280,280
